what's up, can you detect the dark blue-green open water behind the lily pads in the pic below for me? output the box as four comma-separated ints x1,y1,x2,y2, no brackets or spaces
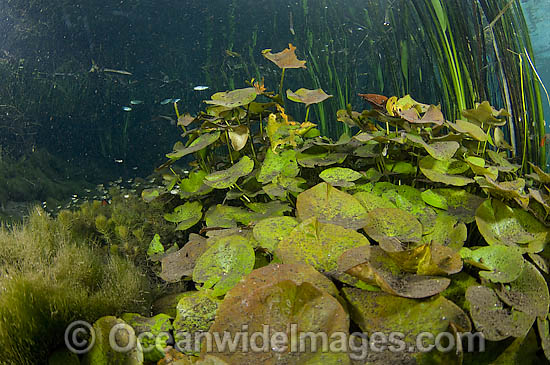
0,0,550,216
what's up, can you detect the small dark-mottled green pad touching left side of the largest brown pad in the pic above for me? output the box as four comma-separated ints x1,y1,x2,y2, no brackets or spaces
173,290,222,354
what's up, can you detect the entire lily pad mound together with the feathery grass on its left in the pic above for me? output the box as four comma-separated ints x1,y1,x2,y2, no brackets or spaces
0,45,550,364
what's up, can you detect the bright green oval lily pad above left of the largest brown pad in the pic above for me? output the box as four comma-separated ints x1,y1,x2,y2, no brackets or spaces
193,236,255,297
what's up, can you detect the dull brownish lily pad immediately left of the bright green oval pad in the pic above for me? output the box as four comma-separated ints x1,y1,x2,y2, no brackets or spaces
159,233,213,283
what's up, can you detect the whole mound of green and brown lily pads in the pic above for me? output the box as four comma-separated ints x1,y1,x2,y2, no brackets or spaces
101,46,550,364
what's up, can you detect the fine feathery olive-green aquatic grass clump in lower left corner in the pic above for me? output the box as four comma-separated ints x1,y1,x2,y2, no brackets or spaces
0,208,148,365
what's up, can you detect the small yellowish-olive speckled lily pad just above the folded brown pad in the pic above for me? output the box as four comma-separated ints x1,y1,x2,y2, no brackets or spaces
363,208,422,242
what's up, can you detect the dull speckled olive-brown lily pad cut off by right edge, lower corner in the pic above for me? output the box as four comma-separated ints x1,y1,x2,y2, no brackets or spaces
495,261,550,318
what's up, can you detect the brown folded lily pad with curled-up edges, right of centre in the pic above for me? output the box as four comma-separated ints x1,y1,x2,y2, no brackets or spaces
338,246,451,298
